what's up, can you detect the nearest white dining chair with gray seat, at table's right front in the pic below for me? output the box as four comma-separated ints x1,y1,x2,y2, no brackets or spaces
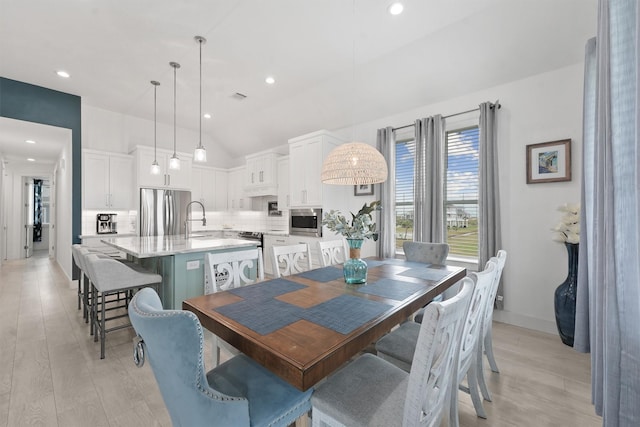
311,278,473,427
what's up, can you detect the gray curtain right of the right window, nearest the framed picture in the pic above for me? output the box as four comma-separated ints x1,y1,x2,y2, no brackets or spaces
478,102,503,302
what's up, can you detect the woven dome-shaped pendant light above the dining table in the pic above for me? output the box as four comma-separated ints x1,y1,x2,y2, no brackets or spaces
321,142,388,185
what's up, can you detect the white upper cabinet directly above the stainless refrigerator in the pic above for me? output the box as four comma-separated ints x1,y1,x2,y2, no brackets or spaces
133,146,192,190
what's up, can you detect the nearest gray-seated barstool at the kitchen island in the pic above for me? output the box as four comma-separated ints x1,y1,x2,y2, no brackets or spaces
85,253,162,359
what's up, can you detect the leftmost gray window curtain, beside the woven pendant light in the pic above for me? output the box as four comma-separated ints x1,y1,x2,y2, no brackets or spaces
377,127,396,258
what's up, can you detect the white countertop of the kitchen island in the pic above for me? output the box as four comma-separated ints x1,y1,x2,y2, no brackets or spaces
101,236,256,258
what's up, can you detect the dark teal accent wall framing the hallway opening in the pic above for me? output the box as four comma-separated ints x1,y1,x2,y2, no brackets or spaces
0,77,82,252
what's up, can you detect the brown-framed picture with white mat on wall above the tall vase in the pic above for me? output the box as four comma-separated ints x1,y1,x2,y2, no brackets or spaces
527,139,571,184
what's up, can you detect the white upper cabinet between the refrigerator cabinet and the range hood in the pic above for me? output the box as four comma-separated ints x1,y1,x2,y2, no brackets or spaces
191,166,227,211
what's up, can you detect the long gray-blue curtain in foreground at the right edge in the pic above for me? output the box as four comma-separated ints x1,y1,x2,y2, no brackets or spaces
575,0,640,427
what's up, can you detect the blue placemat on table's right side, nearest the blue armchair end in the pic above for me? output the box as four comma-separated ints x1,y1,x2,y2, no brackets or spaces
301,295,392,335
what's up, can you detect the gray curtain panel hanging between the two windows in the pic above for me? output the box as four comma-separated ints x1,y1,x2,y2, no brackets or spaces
413,114,445,243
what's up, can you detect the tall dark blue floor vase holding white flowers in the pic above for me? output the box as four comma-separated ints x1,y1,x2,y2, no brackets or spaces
554,243,580,347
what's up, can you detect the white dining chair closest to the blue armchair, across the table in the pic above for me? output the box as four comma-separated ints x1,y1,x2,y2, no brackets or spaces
204,248,264,366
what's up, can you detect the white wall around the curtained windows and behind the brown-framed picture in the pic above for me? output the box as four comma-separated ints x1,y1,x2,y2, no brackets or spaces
336,64,583,333
